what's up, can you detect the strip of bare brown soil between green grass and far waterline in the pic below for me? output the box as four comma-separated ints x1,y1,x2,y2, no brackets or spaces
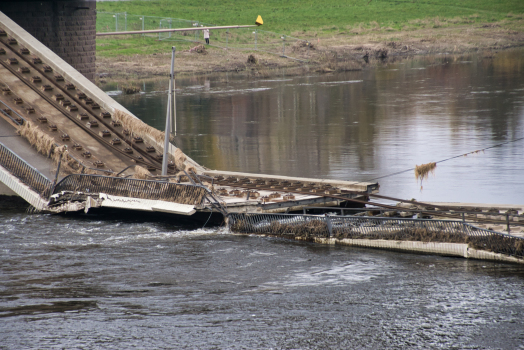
96,21,524,84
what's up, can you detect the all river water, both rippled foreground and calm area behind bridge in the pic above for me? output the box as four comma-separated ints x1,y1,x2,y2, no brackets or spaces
0,51,524,349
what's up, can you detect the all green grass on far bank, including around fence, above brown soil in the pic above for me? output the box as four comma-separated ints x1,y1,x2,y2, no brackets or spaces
97,0,524,57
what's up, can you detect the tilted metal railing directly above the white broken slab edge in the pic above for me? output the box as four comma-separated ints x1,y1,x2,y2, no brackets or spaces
53,174,206,205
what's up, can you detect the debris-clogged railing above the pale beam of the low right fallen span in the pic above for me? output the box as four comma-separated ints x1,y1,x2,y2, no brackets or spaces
228,214,524,257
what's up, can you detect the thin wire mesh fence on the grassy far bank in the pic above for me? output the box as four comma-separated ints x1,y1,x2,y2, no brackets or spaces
96,12,311,61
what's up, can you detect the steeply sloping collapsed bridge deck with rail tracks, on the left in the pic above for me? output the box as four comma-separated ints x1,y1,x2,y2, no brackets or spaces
0,13,378,216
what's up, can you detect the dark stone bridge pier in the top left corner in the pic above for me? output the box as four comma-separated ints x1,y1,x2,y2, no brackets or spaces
0,0,96,81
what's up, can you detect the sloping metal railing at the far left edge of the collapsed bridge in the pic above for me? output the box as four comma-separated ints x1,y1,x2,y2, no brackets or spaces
0,143,52,198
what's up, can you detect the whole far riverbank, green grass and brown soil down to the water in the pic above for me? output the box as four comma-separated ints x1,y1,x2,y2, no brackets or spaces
93,0,524,79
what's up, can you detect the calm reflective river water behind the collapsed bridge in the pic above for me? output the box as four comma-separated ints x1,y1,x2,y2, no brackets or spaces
108,50,524,204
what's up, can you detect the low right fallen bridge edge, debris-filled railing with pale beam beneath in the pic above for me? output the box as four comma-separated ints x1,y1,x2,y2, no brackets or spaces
228,214,524,264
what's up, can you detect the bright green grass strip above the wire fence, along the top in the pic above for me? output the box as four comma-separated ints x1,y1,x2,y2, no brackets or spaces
97,0,524,34
